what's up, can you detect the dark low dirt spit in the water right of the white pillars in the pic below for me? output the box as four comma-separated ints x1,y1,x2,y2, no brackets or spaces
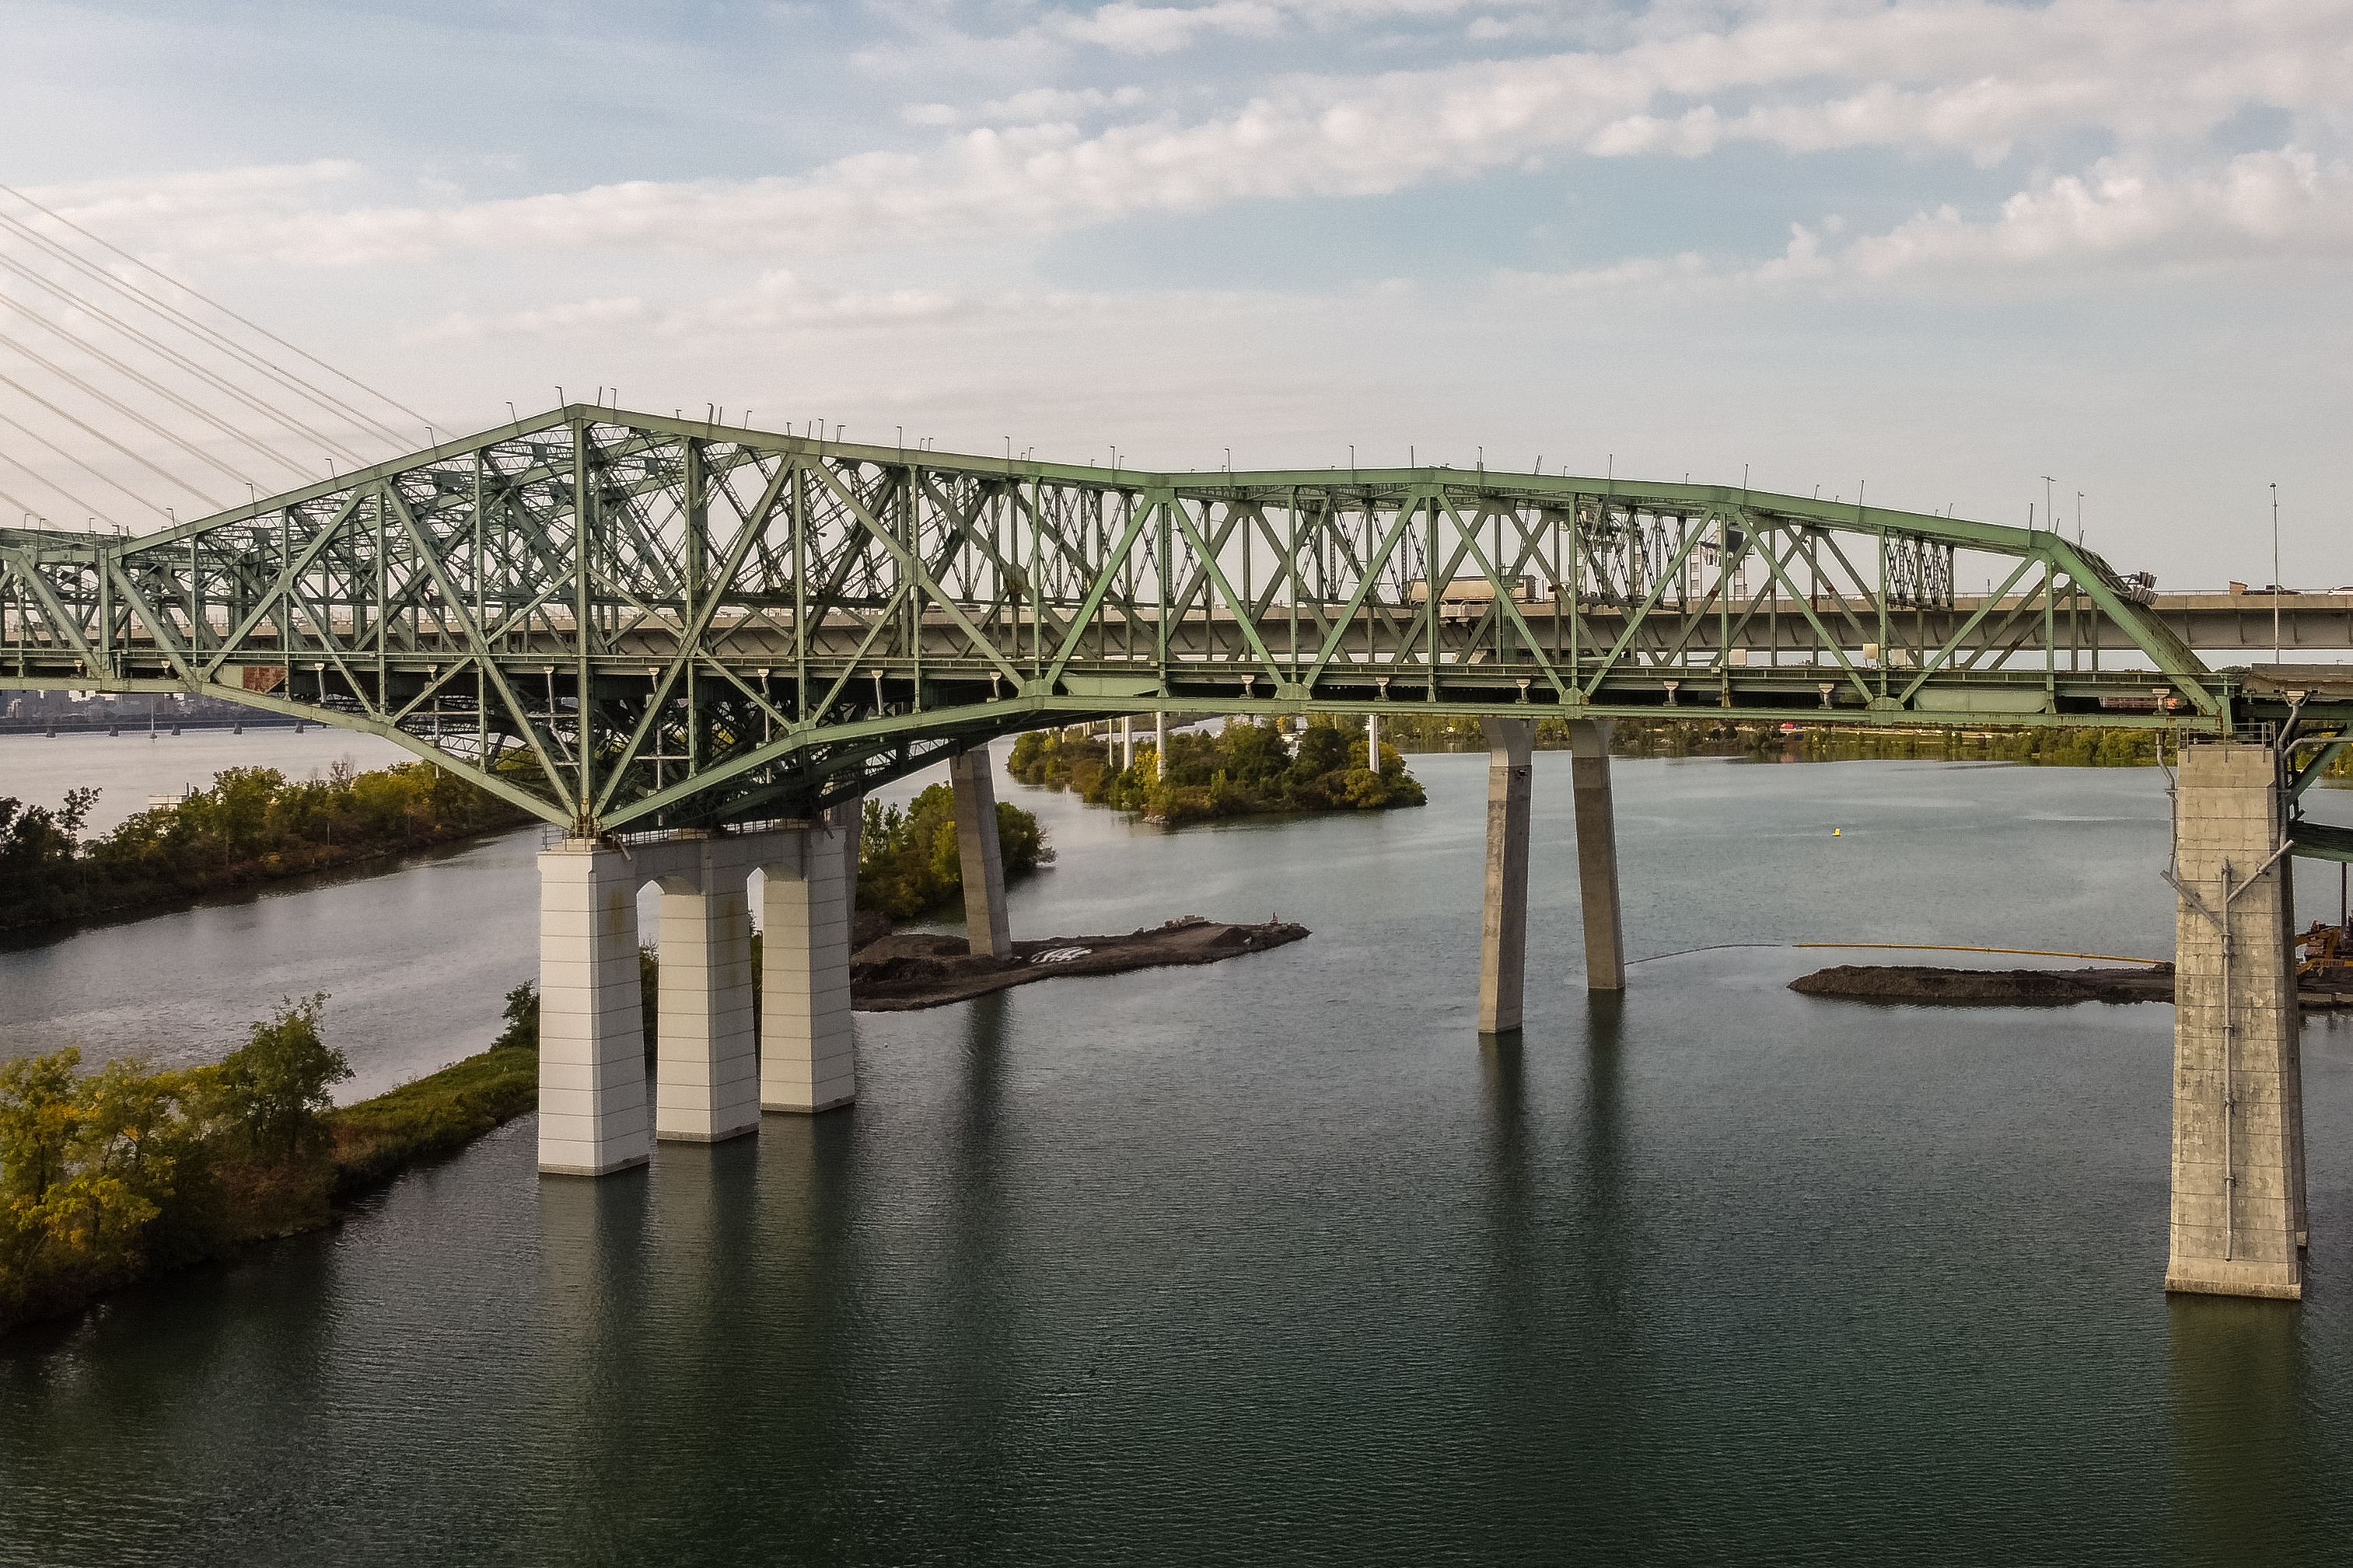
849,914,1308,1013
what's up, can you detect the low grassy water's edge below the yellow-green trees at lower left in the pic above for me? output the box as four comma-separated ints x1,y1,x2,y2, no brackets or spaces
0,1046,539,1338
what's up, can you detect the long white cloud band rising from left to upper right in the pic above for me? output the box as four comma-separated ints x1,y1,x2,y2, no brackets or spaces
41,0,2353,266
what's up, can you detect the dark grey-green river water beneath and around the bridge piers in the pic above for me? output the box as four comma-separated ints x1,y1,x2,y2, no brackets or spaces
0,755,2353,1563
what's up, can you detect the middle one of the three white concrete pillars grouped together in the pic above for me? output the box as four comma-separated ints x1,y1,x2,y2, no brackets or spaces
654,872,760,1143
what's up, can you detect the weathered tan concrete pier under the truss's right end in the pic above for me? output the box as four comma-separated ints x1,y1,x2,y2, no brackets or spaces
2165,746,2303,1300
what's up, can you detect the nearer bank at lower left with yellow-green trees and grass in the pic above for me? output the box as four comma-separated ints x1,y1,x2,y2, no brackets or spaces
0,987,539,1336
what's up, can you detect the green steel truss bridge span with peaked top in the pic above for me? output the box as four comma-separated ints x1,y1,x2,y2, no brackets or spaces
0,404,2285,837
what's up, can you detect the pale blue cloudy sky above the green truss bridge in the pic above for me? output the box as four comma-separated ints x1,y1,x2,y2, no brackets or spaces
0,0,2353,588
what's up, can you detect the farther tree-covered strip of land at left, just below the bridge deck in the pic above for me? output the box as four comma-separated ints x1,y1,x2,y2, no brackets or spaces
0,757,537,931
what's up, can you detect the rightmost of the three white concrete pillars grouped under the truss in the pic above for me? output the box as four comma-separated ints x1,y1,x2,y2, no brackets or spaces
760,827,858,1112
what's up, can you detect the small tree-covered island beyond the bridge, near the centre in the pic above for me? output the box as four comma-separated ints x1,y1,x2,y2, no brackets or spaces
1005,714,1421,827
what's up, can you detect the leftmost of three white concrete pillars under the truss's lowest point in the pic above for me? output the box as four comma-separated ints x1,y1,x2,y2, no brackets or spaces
539,840,649,1175
